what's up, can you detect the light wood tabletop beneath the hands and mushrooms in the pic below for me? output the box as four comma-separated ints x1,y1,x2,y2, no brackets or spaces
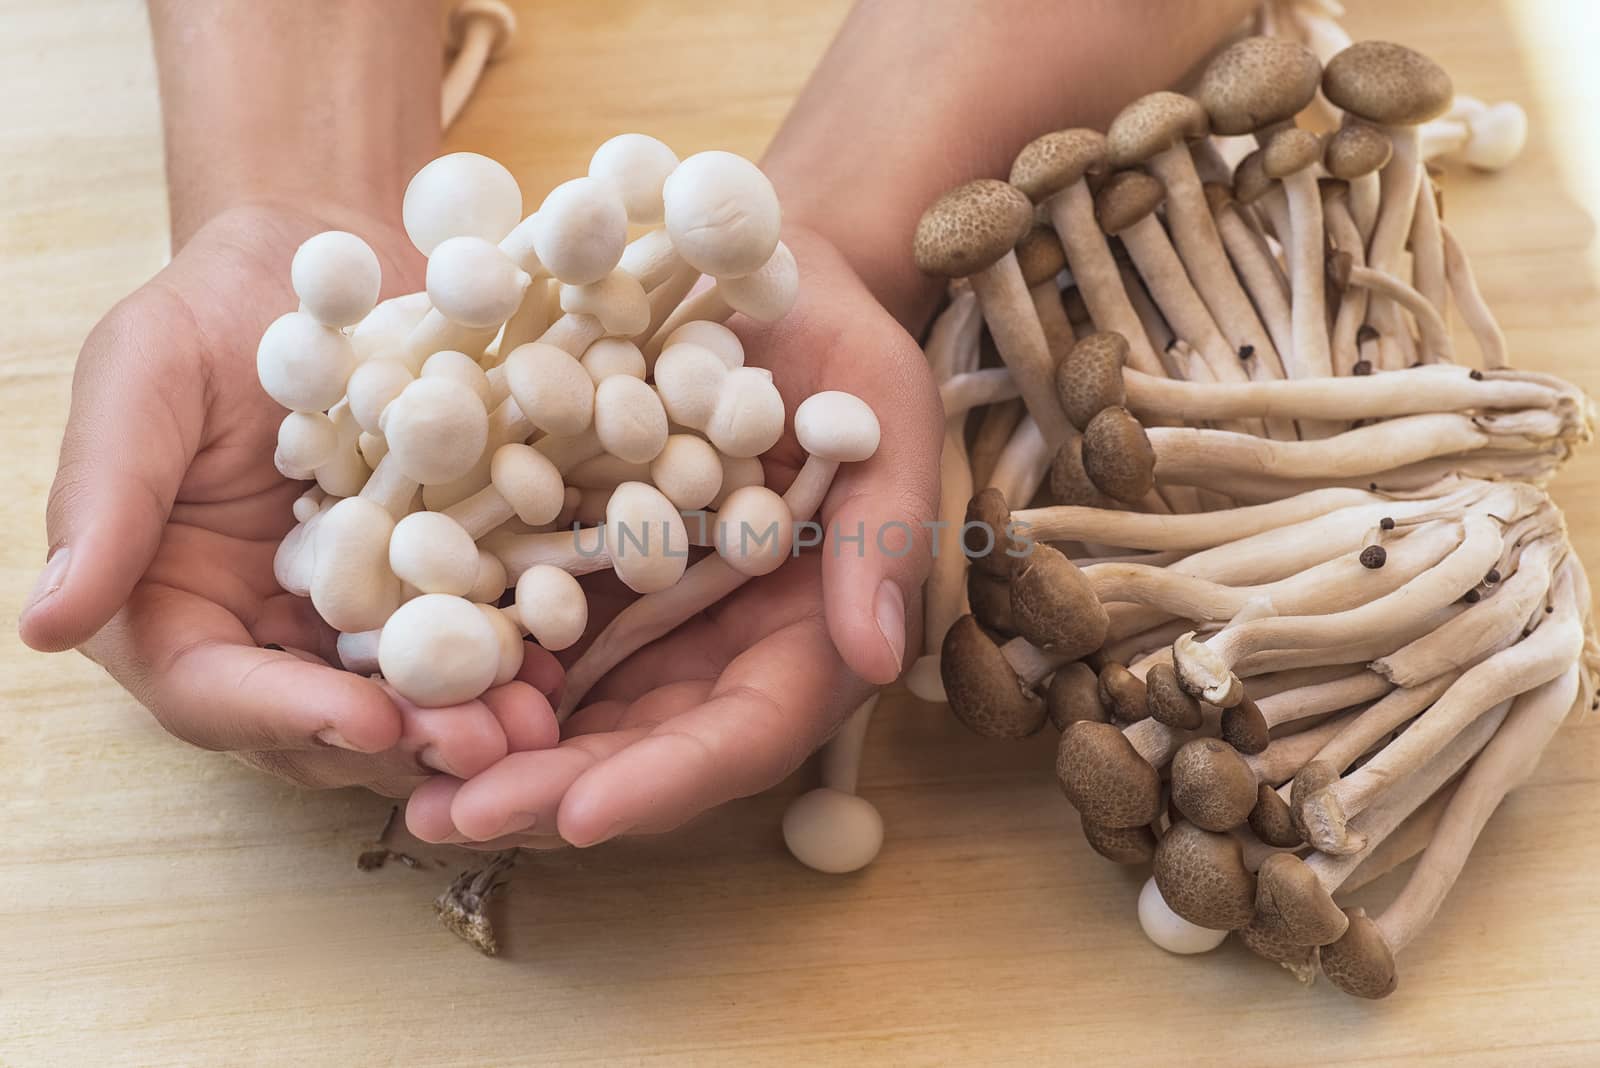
0,0,1600,1068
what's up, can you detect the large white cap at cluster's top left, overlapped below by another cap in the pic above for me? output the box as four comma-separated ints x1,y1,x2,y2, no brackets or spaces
400,152,522,256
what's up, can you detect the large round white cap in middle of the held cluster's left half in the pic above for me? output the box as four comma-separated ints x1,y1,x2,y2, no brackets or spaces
381,379,490,486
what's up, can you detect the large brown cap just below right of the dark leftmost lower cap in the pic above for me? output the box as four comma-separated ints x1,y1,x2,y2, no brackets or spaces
1056,719,1162,827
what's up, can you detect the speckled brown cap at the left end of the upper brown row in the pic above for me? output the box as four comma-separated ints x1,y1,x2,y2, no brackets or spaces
912,177,1034,278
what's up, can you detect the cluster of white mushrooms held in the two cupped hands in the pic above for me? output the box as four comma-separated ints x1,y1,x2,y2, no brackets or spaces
258,134,878,718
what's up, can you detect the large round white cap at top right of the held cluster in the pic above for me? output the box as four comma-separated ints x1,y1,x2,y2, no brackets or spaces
661,152,782,278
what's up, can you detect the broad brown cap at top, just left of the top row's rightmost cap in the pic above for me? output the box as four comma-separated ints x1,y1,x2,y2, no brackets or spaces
1198,37,1322,134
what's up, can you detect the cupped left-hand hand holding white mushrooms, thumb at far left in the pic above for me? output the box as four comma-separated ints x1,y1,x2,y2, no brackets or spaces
21,206,560,795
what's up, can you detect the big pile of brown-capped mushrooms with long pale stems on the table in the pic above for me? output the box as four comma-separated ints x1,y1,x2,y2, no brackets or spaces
910,20,1595,998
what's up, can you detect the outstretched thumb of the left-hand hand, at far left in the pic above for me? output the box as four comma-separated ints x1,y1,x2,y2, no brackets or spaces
18,286,205,652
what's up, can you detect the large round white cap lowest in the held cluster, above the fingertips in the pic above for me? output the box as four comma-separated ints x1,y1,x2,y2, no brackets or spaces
378,593,501,708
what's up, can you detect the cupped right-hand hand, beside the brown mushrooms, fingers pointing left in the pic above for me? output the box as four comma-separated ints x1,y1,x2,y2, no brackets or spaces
406,229,942,847
